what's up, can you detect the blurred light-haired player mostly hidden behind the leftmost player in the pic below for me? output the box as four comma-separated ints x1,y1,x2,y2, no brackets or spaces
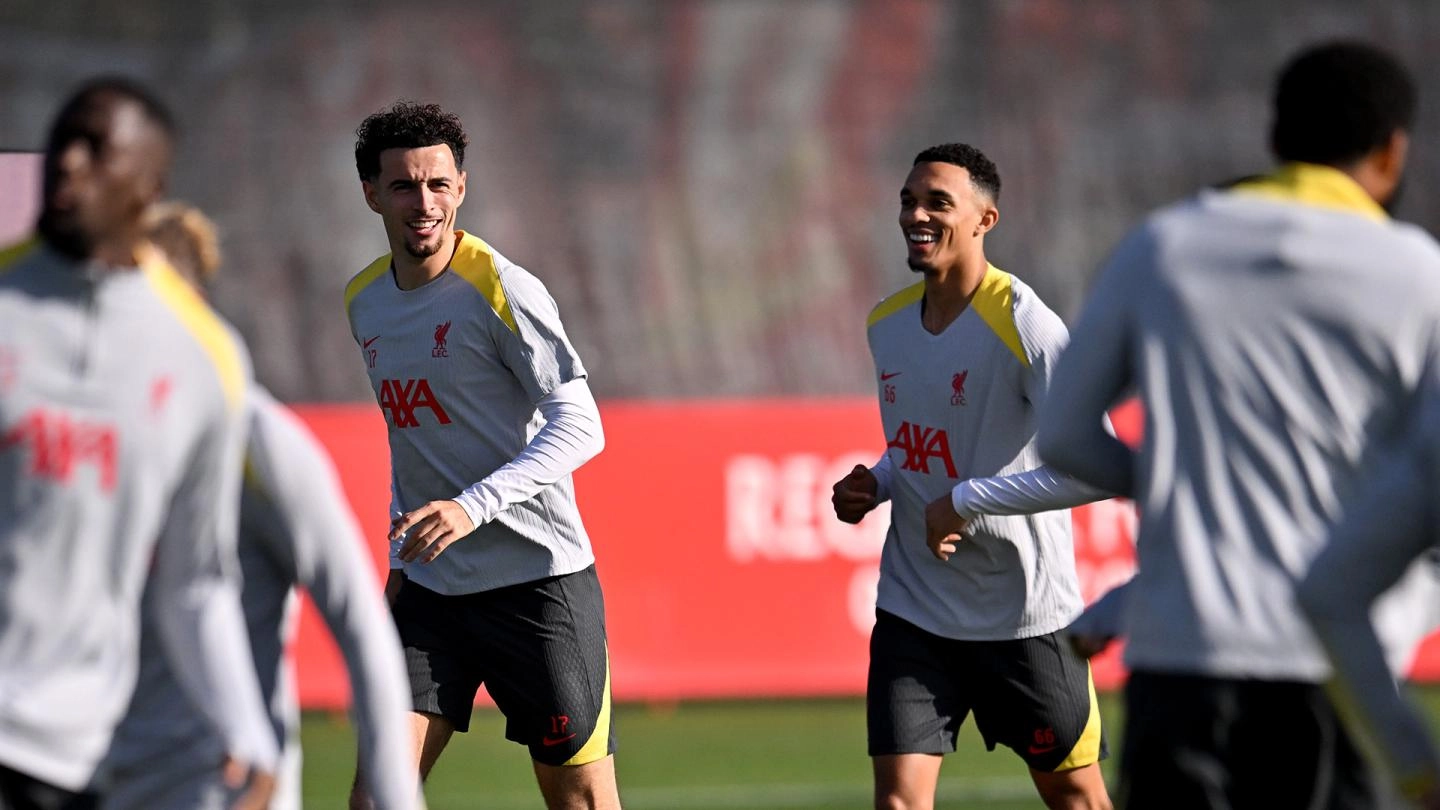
102,203,419,810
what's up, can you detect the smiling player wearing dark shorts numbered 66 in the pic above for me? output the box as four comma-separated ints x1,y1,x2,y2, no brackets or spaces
834,144,1110,809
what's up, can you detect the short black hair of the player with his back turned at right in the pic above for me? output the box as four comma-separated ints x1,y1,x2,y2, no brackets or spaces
1270,40,1417,166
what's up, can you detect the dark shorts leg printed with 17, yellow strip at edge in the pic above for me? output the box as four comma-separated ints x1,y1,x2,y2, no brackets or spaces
475,566,615,765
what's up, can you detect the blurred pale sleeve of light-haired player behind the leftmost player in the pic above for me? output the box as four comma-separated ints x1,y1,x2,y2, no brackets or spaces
251,404,419,810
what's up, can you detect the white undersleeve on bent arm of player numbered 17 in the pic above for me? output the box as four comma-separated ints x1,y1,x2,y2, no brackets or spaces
455,378,605,526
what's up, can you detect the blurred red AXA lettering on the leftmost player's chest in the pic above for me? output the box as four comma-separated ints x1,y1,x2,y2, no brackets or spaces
0,408,120,494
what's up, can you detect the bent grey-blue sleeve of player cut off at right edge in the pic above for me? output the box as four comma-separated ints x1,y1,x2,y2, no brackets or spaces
1296,442,1440,785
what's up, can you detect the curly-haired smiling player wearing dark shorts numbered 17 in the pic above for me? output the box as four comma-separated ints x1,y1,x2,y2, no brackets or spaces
346,102,619,809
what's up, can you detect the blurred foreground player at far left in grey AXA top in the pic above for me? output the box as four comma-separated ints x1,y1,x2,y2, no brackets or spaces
0,79,278,810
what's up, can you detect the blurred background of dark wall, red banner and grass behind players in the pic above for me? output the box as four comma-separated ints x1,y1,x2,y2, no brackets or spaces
0,0,1440,809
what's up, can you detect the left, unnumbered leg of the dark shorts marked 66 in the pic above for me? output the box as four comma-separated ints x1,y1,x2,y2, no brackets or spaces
865,610,971,757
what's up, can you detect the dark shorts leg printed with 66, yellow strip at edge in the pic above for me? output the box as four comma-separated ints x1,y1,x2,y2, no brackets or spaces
969,633,1106,773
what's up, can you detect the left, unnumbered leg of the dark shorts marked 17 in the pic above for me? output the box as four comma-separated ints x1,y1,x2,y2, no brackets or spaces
390,581,485,732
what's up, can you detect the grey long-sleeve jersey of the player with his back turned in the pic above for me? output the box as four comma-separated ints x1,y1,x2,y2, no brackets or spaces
1040,164,1440,683
